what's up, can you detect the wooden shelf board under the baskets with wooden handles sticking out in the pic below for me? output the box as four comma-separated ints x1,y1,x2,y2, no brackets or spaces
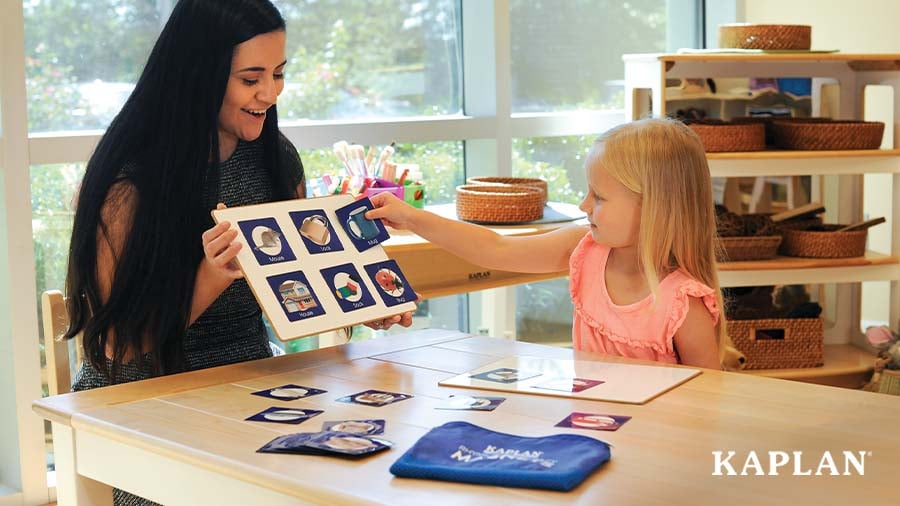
718,251,900,287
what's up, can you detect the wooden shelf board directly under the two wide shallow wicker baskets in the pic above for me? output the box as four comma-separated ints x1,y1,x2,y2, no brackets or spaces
706,149,900,177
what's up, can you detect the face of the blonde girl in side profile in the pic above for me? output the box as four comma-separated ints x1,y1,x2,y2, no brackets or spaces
578,145,641,248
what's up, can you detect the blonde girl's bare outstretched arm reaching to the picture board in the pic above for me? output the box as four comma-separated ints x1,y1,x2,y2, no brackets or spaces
366,192,588,273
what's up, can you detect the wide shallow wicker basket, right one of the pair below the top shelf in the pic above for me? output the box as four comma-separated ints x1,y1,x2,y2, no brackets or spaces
772,121,884,151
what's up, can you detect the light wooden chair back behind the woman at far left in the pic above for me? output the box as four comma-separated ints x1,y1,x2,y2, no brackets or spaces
41,290,82,395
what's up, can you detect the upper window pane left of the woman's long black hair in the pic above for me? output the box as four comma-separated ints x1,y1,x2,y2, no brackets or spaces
23,0,165,132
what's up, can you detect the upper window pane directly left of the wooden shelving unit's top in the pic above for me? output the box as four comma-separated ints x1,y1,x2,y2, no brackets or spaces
510,0,667,112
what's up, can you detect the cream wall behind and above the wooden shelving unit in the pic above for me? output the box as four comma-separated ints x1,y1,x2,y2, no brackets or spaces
737,0,900,330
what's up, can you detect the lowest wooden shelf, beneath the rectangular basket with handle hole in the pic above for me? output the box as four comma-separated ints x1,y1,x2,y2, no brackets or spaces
744,344,875,388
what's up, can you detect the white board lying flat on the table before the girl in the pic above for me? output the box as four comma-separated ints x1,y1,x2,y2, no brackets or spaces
438,357,700,404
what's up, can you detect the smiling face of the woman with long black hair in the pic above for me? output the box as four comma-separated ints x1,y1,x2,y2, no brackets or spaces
219,31,287,153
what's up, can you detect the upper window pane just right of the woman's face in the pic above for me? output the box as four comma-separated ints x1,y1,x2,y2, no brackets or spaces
278,0,462,120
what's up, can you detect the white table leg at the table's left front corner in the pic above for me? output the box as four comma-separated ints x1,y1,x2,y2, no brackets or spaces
51,423,112,506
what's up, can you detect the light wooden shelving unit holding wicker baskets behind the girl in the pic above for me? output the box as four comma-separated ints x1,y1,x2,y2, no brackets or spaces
624,53,900,386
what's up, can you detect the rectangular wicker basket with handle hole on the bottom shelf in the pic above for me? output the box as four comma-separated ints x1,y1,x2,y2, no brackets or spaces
726,318,825,369
